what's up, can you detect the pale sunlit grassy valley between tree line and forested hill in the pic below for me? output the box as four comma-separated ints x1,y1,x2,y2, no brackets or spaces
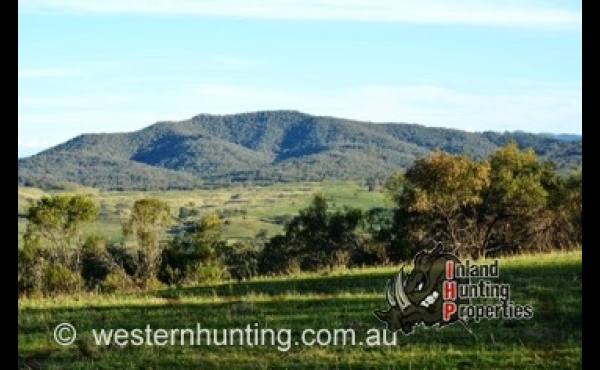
18,182,391,245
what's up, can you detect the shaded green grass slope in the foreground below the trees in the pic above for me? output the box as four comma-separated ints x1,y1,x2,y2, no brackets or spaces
18,251,582,369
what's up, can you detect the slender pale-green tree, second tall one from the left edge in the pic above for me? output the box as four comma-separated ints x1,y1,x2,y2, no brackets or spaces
123,198,172,285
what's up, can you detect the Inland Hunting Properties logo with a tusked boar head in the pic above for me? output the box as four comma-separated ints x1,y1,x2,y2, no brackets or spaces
373,243,533,334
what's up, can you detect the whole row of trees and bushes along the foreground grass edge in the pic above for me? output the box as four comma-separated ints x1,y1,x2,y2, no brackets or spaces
18,142,583,297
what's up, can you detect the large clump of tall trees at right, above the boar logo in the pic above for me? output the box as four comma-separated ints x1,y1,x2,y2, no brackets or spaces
387,142,581,258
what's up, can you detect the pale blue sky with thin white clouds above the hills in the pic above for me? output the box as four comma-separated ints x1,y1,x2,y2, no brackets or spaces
18,0,582,158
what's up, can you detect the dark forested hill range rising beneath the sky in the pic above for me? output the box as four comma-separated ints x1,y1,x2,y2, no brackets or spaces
18,111,583,190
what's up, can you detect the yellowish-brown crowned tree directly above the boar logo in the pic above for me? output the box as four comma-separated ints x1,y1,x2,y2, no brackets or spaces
386,151,490,256
